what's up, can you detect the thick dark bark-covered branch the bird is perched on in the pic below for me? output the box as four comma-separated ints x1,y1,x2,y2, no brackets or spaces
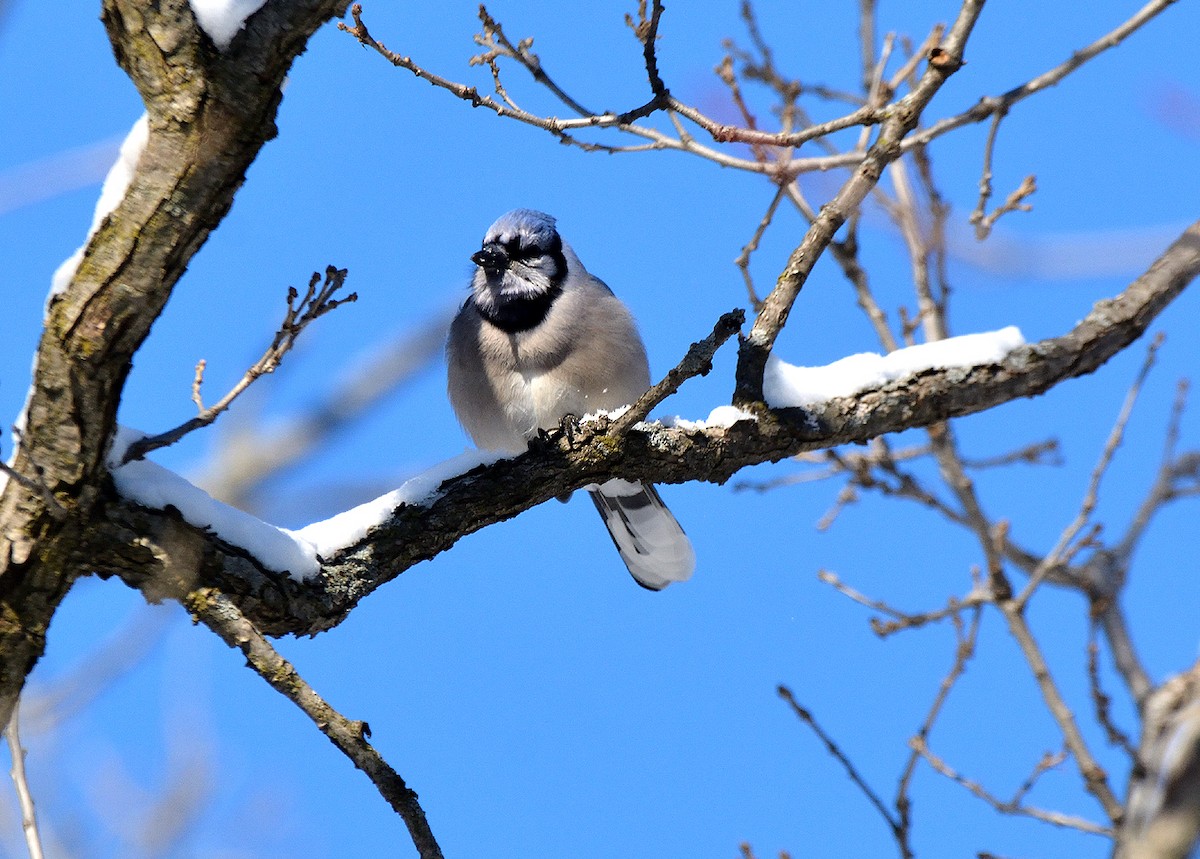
100,223,1200,635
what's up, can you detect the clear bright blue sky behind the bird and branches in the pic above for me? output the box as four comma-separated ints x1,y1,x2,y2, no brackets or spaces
0,0,1200,857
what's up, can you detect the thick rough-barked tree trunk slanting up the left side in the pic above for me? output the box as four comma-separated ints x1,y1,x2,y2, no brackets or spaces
0,0,346,720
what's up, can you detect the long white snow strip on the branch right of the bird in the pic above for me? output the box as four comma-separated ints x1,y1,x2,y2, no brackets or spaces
762,325,1025,409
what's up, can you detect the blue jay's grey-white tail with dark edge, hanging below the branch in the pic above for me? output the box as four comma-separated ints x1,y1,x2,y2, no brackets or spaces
589,479,696,590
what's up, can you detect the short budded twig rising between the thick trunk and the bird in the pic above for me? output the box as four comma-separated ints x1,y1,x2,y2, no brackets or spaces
122,265,359,463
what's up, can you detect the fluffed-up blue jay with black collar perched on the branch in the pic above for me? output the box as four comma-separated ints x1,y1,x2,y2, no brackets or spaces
446,209,696,590
